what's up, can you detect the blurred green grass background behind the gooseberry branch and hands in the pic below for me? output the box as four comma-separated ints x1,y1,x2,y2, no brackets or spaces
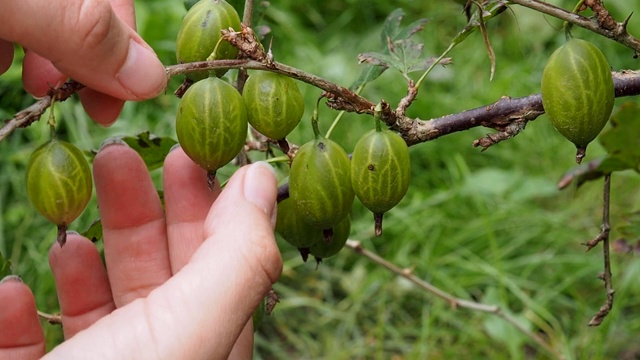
0,0,640,359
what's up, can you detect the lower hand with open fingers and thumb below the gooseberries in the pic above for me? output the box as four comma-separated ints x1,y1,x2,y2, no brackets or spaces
0,144,282,359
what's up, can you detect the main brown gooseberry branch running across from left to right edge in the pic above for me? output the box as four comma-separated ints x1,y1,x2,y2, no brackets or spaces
0,59,640,148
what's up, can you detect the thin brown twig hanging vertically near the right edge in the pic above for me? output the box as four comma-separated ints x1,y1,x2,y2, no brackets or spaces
589,174,615,326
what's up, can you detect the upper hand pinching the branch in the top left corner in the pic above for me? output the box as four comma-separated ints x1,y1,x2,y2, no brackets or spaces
0,0,167,126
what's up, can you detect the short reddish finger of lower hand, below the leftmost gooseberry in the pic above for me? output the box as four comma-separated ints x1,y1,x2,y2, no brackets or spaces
49,233,115,339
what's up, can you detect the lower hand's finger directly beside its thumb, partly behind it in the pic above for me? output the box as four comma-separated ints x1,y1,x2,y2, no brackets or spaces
163,148,220,274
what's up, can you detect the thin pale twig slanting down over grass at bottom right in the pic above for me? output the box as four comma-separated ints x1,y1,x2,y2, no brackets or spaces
347,240,561,358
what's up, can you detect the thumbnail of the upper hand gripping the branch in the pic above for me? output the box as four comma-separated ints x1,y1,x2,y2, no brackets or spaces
116,40,167,99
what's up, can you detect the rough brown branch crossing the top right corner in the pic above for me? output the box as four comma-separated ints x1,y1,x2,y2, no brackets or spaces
509,0,640,53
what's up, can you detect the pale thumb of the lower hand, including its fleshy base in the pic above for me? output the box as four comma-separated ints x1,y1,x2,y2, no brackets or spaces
46,163,282,359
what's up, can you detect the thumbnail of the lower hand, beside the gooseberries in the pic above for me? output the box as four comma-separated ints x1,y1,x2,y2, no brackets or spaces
244,161,276,217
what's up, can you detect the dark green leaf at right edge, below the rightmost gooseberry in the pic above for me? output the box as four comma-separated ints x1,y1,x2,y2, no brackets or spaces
598,102,640,173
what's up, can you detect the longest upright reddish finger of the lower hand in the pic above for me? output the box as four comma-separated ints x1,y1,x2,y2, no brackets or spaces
93,143,171,307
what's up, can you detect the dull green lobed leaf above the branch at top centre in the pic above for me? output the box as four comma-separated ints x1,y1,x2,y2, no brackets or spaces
351,9,428,89
